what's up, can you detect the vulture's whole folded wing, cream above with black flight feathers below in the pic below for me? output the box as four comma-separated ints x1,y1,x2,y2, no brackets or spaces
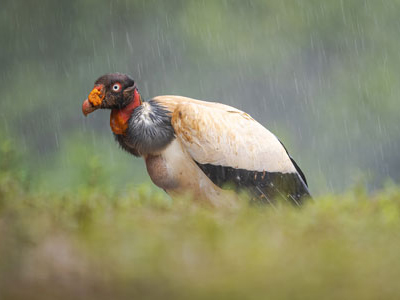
153,96,309,204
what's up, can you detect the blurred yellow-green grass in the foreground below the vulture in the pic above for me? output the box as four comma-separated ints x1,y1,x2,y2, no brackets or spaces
0,166,400,299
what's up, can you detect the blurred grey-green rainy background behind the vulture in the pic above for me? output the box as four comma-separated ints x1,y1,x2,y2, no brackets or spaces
0,0,400,194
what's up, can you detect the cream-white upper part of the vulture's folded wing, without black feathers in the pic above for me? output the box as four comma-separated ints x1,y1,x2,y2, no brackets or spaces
153,96,296,173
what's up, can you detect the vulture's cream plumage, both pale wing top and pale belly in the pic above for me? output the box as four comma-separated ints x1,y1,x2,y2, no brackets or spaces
144,96,296,206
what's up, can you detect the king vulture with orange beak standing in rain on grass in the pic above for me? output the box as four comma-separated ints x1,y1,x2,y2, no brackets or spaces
82,73,311,207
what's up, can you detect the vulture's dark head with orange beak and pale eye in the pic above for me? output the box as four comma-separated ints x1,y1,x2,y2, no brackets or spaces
82,73,141,116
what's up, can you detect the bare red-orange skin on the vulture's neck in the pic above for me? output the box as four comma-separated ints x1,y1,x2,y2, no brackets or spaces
110,88,142,134
